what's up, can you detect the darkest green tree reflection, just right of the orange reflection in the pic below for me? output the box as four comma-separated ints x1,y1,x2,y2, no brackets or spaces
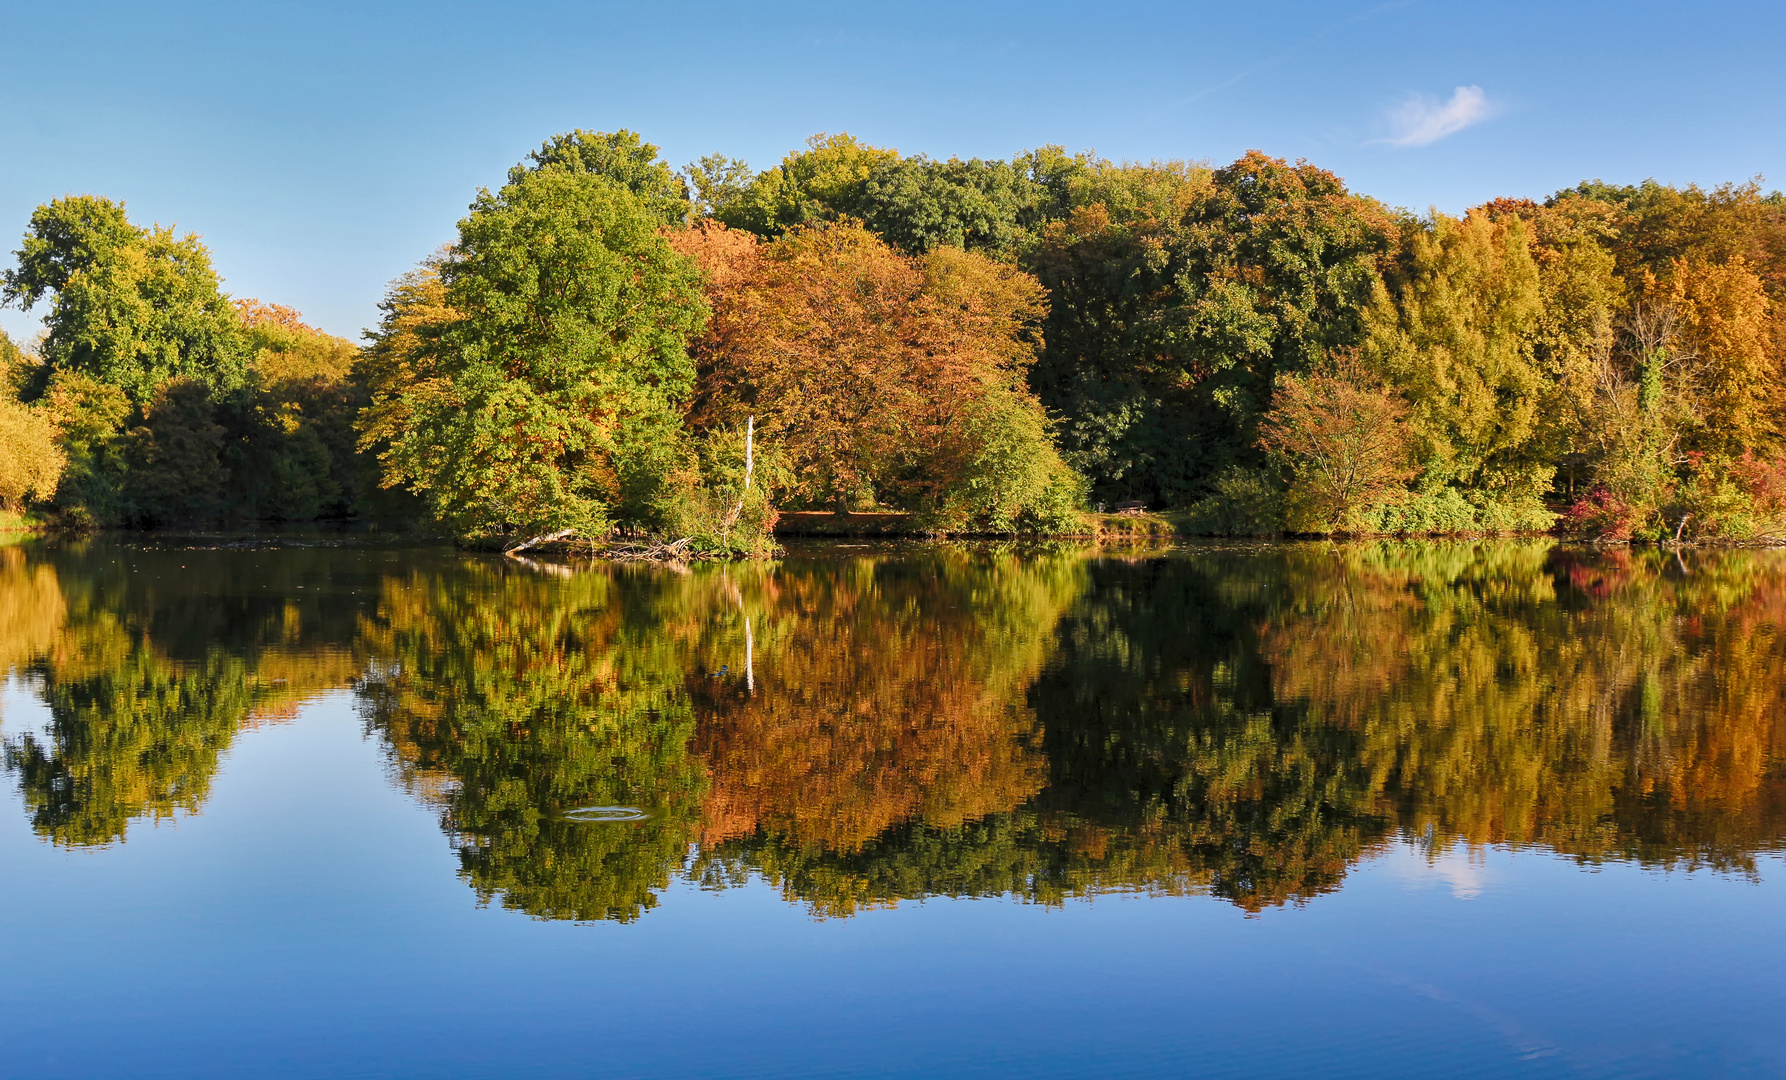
1031,559,1388,907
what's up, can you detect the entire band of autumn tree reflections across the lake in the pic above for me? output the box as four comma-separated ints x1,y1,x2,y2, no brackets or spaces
0,541,1786,919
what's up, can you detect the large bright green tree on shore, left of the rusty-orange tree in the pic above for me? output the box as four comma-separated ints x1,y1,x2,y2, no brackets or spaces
375,166,707,536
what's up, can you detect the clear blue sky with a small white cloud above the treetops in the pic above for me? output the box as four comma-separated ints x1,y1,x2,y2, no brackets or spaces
0,0,1786,336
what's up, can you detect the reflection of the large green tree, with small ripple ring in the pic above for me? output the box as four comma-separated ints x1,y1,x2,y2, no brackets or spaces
363,561,705,919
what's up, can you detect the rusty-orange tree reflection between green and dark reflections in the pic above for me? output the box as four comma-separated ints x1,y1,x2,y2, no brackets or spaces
697,552,1079,853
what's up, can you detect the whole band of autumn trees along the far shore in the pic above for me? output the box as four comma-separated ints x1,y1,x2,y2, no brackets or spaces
0,130,1786,553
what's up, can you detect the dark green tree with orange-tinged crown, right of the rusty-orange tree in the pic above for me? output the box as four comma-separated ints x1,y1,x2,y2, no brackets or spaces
1027,152,1400,503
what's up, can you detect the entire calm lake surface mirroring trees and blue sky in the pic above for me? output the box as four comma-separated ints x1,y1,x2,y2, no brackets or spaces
0,541,1786,1078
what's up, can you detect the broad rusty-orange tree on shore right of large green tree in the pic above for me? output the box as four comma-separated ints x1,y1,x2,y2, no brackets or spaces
672,223,1077,528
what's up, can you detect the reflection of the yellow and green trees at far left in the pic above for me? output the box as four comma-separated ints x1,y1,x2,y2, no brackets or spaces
0,542,357,844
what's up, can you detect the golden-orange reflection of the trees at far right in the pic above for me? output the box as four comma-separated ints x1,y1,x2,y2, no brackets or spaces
1261,544,1786,869
